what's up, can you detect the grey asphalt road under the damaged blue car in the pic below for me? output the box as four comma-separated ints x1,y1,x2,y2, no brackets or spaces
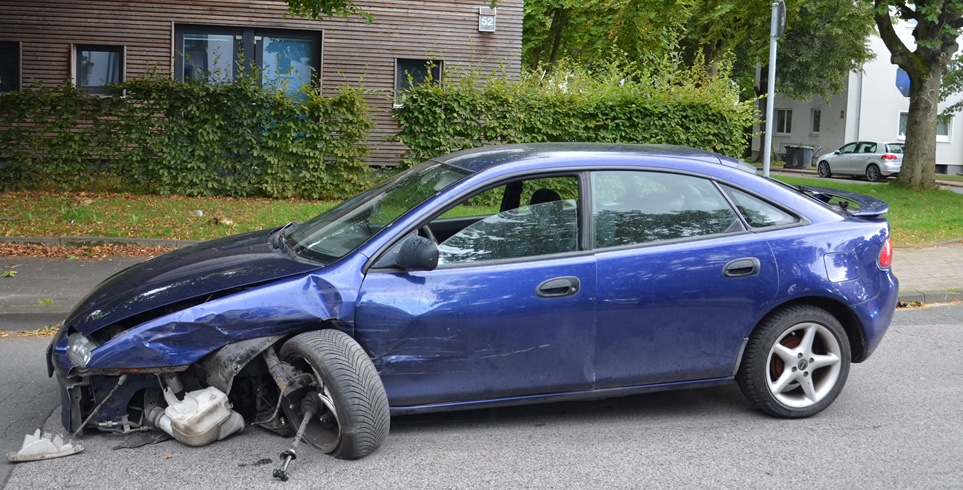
0,304,963,489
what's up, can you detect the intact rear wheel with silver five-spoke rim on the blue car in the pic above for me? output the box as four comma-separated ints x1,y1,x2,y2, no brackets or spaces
736,305,850,419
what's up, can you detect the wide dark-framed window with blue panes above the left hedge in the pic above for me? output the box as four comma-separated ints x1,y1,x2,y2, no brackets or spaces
174,26,321,94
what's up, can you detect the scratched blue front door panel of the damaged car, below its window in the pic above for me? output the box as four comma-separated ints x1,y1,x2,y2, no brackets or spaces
355,255,596,407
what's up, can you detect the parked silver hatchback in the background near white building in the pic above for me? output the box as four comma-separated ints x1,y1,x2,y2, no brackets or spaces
816,141,903,182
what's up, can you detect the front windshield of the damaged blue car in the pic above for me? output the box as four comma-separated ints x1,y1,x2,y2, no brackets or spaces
284,162,469,263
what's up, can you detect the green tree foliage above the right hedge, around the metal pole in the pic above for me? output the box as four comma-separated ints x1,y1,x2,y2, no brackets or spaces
522,0,874,160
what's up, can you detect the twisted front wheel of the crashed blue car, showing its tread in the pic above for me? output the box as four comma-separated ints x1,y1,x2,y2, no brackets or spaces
279,329,391,459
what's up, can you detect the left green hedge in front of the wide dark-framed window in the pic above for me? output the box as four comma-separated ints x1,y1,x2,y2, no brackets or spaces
0,76,372,199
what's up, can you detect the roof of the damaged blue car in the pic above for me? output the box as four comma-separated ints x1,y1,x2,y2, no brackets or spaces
434,143,756,173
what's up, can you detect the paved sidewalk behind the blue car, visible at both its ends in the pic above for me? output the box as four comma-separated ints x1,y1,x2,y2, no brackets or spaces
0,236,963,331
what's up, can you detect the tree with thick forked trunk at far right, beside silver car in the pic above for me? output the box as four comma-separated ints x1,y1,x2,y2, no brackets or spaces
873,0,963,188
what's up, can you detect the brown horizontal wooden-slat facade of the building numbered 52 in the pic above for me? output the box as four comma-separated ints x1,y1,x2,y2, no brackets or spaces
0,0,522,165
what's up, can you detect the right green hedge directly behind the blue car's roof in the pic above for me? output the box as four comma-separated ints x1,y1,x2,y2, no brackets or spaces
397,62,754,165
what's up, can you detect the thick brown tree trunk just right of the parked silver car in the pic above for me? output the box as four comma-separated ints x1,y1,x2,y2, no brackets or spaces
899,70,941,189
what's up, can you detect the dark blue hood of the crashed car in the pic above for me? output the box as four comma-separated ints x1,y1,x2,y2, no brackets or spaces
64,230,321,335
